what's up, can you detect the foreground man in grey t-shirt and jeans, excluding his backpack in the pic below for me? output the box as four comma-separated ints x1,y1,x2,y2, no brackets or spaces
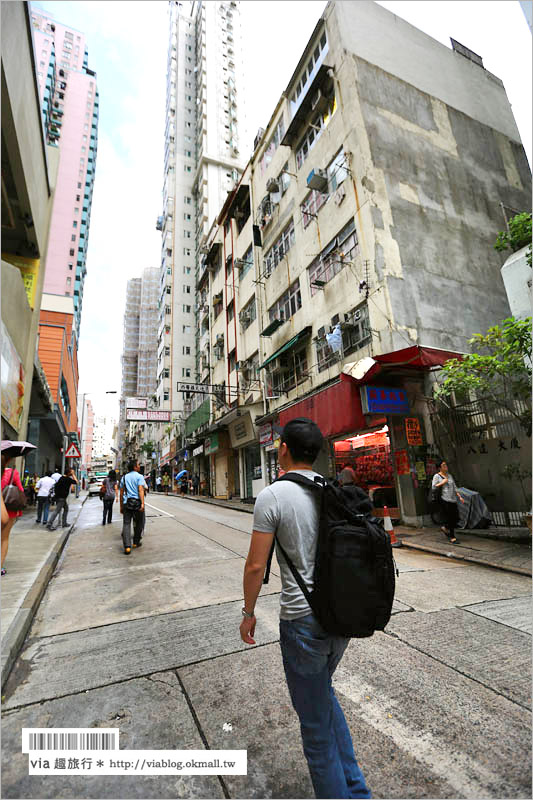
240,417,371,798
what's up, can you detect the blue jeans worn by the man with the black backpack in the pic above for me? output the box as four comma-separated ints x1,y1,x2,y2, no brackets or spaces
279,614,372,799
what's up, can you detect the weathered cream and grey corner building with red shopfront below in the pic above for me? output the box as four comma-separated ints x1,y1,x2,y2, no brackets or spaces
182,2,531,521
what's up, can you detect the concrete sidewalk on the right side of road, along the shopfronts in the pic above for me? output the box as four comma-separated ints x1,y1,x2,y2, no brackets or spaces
164,492,531,575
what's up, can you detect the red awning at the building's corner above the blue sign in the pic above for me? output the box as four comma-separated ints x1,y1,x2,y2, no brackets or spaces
342,345,464,384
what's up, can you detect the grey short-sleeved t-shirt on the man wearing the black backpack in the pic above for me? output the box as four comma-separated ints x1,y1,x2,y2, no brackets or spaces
253,469,320,619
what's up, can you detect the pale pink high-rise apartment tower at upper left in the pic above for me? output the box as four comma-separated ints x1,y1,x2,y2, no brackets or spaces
32,9,99,341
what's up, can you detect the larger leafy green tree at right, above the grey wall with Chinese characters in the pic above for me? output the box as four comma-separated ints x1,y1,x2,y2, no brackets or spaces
435,317,531,435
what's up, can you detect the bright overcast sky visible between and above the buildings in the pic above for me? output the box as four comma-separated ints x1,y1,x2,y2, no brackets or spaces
31,0,532,416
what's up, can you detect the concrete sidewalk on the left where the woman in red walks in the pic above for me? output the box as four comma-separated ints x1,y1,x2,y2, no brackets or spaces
0,491,87,687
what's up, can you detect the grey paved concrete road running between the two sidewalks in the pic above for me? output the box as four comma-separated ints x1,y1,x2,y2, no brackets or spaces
2,495,531,798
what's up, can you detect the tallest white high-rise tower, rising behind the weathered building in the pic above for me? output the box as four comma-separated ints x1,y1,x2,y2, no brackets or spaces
156,0,246,438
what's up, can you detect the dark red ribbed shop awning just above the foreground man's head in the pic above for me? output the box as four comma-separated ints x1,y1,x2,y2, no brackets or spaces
279,374,368,437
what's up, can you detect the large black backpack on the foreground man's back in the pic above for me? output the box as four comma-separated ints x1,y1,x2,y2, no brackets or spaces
263,472,398,639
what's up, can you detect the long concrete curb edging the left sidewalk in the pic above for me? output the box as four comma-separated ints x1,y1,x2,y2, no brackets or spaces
2,495,88,691
